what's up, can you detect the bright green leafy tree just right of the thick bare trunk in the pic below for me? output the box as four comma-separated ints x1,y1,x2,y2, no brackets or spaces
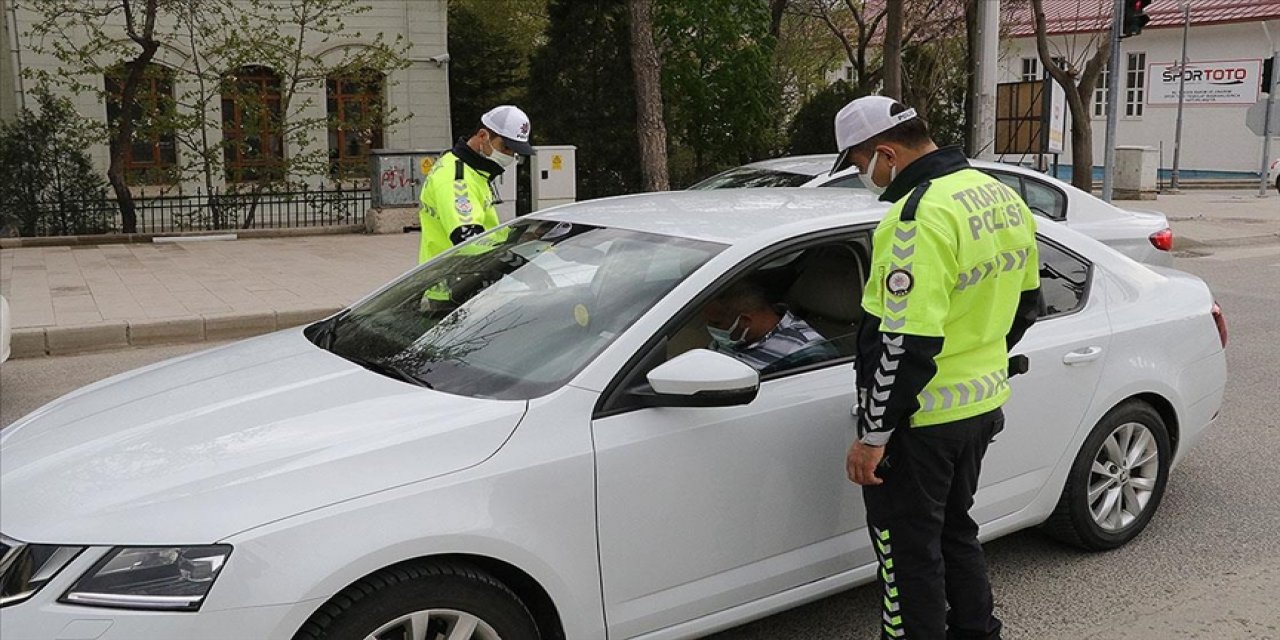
655,0,781,186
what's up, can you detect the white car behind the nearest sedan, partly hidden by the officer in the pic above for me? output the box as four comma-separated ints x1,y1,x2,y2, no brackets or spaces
690,154,1174,266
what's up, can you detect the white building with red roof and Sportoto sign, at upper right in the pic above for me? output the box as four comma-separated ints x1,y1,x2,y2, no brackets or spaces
1000,0,1280,179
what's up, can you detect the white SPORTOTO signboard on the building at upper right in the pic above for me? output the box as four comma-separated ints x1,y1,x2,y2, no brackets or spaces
1147,60,1262,106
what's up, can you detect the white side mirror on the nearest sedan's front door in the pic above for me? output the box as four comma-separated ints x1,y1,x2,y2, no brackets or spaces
632,349,760,407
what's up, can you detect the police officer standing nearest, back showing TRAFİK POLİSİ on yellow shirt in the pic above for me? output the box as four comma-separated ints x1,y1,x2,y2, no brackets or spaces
833,96,1041,640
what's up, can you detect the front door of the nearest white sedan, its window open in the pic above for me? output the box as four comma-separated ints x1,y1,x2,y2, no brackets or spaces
593,238,873,637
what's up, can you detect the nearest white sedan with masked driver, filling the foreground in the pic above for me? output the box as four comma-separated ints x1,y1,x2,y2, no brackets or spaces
0,189,1226,640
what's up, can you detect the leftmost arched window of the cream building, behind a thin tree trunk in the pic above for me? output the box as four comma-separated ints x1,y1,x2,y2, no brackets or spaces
104,64,178,184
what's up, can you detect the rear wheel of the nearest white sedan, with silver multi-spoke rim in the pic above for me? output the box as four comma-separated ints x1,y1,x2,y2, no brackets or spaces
1042,401,1172,550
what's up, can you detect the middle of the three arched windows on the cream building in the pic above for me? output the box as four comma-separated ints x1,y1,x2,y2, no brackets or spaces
223,67,284,182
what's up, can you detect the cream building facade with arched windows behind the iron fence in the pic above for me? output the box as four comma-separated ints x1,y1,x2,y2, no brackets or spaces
0,0,452,191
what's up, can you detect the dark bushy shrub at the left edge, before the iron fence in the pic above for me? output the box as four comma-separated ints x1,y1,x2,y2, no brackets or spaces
0,88,114,236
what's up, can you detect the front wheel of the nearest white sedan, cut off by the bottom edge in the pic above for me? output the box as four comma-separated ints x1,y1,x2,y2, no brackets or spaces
293,562,539,640
